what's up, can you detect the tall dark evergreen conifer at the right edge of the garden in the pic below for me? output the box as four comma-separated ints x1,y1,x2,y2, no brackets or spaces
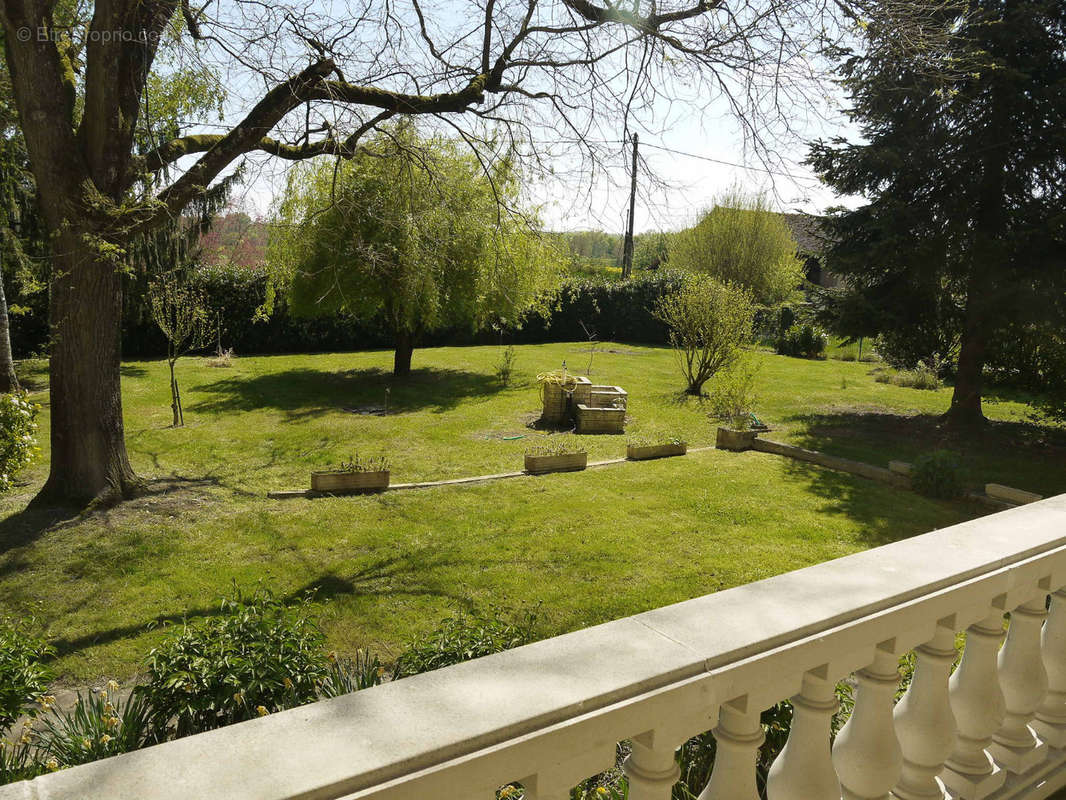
810,0,1066,426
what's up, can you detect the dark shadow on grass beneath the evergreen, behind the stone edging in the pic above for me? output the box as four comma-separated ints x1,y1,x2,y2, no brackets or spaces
786,411,1066,496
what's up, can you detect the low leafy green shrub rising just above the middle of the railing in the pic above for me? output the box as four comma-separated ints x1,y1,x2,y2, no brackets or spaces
393,609,537,678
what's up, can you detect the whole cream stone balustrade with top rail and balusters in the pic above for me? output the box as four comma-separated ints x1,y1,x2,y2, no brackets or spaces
0,495,1066,800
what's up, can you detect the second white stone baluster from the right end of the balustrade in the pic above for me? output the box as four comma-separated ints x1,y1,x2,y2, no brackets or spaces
988,592,1048,773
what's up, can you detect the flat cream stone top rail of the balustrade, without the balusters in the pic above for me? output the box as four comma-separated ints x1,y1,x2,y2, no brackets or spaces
8,495,1066,800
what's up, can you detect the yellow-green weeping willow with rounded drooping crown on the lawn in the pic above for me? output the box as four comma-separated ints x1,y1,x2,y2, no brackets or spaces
271,124,562,377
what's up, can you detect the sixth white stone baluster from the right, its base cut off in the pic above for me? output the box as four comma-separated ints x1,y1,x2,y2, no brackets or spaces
766,668,840,800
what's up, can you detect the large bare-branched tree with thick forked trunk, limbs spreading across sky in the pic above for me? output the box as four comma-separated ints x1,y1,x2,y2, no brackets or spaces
0,0,955,501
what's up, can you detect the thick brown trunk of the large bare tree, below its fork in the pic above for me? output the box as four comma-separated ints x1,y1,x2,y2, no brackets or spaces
36,226,141,505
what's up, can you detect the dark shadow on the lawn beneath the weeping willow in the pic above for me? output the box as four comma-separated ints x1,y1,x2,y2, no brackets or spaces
185,367,504,419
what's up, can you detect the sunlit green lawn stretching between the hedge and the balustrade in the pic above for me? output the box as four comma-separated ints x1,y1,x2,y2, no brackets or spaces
0,345,1066,682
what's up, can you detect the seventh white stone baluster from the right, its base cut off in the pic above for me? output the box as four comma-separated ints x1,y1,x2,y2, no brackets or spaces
699,698,765,800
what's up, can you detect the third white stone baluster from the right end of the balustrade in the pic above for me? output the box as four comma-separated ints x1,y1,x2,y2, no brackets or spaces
940,610,1006,800
